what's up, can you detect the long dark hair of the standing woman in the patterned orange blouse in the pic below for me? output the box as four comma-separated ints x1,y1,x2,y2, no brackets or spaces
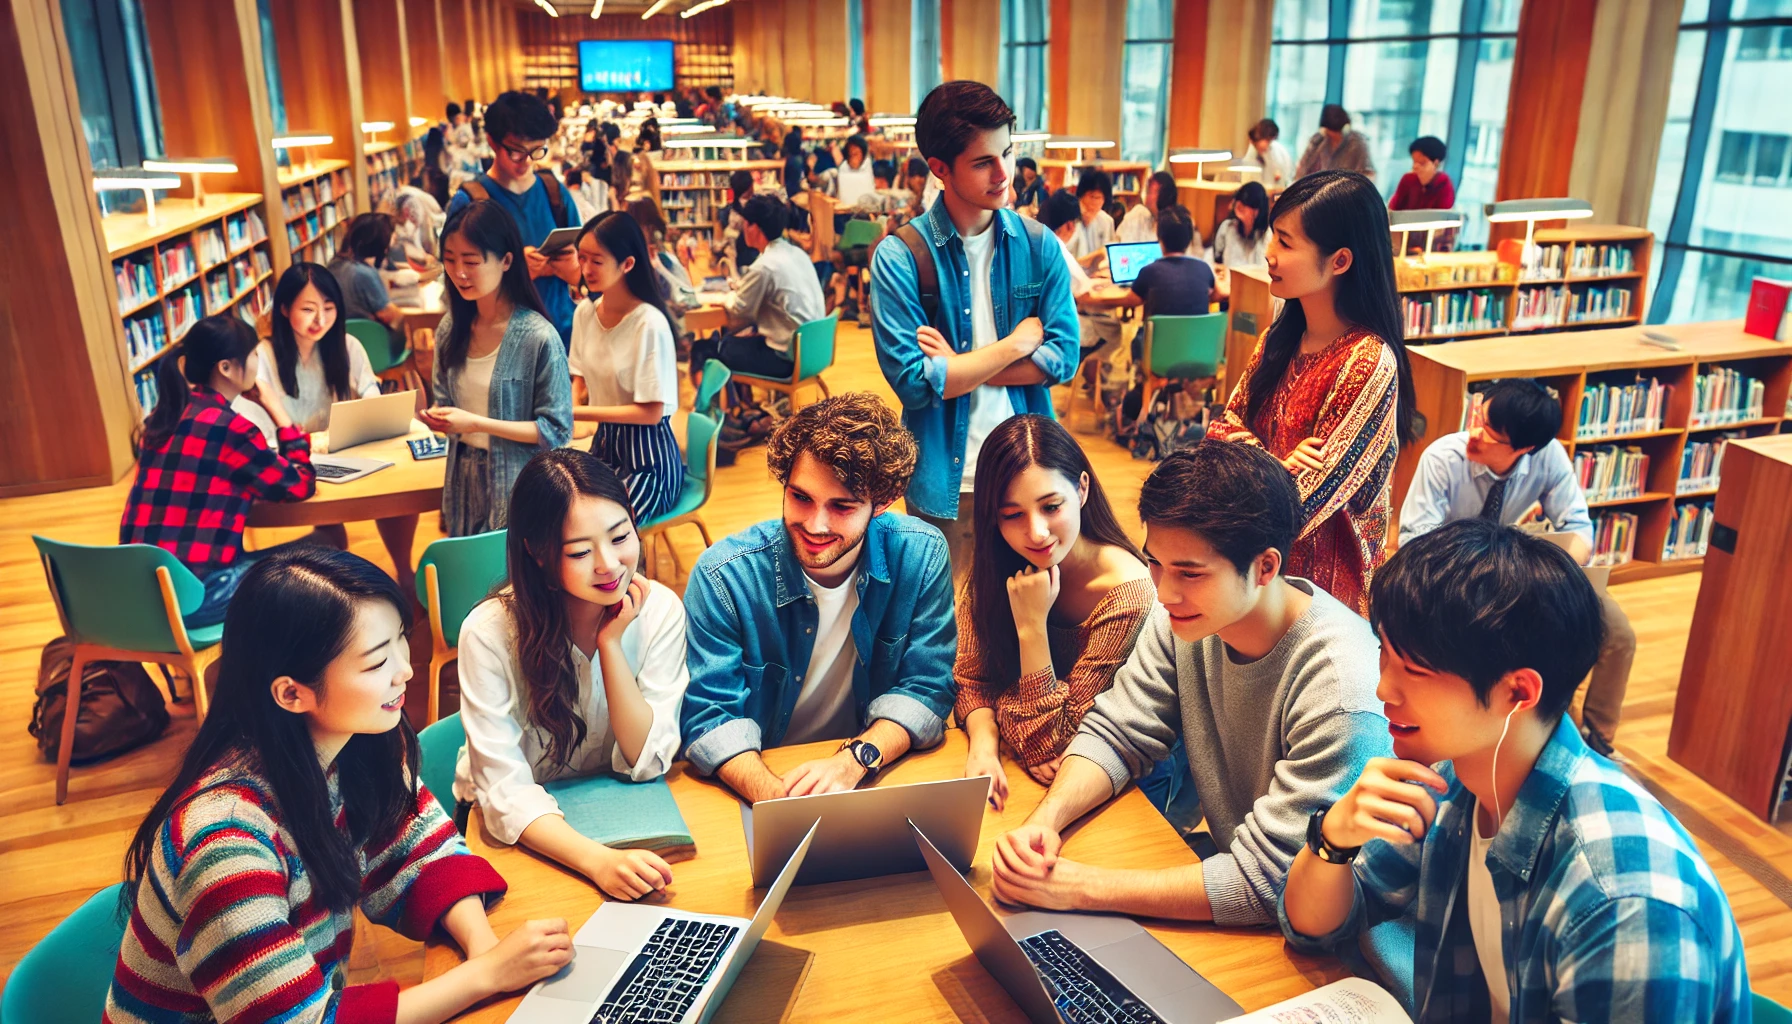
1245,170,1417,445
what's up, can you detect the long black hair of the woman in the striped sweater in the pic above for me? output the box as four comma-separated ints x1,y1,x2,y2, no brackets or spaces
124,545,418,911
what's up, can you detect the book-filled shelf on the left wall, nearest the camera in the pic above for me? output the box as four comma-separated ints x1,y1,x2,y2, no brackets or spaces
100,192,274,416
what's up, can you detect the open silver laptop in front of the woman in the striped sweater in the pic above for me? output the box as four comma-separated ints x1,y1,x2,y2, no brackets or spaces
509,829,815,1024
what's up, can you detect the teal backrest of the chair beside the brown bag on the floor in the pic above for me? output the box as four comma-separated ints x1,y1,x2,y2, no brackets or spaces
30,534,206,655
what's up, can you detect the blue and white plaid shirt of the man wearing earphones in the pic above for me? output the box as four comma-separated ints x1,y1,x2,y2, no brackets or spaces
1279,716,1751,1024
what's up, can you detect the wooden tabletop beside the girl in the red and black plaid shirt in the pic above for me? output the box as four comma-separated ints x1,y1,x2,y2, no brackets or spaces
249,420,448,525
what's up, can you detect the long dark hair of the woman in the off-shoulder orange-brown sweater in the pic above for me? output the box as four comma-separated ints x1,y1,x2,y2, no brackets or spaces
968,412,1145,689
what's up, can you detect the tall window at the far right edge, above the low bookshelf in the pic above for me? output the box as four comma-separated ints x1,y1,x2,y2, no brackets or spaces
1649,0,1792,323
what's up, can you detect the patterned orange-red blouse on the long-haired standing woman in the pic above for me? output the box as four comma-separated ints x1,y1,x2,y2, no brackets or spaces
1208,328,1400,615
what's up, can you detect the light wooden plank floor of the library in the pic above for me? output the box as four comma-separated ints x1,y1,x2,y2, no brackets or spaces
10,325,1792,1002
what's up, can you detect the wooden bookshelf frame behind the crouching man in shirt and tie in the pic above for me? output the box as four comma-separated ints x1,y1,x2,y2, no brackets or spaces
1391,319,1792,583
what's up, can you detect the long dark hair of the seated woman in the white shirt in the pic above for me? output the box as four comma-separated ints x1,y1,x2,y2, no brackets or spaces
498,448,634,769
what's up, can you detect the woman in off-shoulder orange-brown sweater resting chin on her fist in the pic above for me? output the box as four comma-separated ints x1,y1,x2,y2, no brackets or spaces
953,414,1154,811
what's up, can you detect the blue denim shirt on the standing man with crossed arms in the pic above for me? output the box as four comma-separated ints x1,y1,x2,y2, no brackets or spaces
871,199,1081,518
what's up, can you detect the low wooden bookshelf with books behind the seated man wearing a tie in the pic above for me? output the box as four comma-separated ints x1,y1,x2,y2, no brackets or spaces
1394,319,1792,583
